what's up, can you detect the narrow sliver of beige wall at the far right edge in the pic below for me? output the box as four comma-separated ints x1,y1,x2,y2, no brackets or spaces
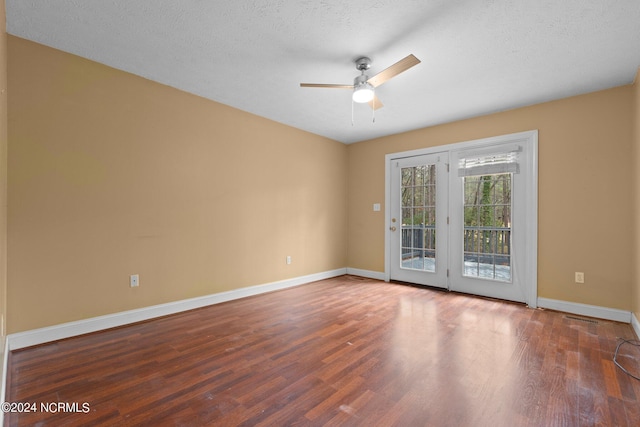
632,68,640,320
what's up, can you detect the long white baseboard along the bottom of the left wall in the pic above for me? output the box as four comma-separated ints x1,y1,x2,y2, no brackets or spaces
5,268,347,353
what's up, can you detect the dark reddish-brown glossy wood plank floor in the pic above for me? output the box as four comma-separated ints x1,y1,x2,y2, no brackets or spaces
5,276,640,426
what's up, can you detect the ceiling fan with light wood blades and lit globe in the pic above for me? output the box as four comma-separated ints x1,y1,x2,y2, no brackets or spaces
300,55,420,110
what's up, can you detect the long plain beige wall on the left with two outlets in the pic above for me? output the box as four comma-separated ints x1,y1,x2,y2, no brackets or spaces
8,36,347,332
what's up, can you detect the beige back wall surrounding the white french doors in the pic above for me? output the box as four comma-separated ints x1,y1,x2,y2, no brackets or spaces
348,86,633,310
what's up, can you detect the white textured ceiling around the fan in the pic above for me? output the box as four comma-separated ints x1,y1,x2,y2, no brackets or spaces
6,0,640,143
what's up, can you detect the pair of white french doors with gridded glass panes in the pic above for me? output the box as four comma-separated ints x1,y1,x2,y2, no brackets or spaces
385,131,537,307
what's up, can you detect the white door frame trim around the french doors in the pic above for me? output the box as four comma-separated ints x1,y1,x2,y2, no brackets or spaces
384,130,538,308
